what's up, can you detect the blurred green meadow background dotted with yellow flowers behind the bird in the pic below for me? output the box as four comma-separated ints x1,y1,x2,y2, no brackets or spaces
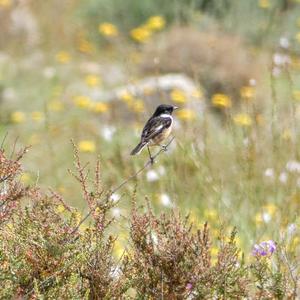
0,0,300,254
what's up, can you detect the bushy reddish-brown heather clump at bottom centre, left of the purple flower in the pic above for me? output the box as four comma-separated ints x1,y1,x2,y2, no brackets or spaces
127,204,248,299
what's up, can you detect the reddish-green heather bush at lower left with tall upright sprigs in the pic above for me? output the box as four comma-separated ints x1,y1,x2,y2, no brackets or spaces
0,144,123,299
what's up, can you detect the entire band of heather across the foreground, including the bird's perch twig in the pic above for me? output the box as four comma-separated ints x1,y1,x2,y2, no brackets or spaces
0,145,298,299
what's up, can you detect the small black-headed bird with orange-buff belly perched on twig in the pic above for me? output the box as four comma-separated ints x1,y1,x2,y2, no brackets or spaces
130,104,178,162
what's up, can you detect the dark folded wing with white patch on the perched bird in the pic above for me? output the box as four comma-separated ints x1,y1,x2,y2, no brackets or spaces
142,116,172,142
